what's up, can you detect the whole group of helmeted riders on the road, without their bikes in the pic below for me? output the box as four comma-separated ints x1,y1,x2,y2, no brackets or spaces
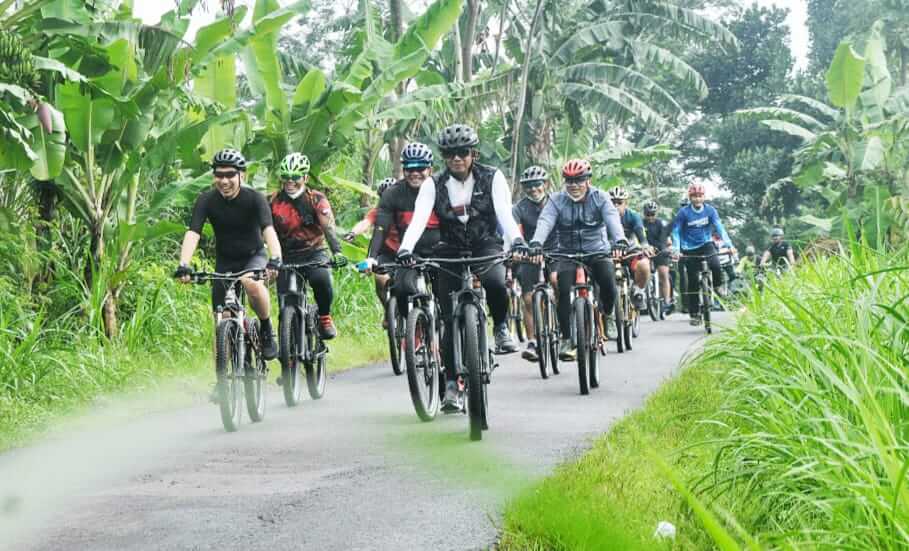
175,124,793,418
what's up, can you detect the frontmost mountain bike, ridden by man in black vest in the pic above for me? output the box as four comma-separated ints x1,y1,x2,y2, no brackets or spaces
422,253,511,440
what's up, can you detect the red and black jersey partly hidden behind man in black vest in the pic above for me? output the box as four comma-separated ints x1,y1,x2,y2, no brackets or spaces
369,180,439,258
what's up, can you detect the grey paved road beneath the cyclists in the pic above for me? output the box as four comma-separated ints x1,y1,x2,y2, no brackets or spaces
0,316,724,551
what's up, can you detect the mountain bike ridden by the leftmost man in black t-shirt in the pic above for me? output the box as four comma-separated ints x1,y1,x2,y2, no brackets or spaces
189,270,268,432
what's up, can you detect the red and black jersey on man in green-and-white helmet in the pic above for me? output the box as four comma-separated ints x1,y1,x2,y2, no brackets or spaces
271,189,341,259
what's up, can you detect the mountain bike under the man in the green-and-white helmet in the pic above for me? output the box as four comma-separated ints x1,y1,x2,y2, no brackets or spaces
278,260,334,407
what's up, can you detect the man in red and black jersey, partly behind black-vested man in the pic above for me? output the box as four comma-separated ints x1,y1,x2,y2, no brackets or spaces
365,142,439,312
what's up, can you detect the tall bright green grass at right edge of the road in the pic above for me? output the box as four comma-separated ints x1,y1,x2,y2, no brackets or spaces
700,246,909,549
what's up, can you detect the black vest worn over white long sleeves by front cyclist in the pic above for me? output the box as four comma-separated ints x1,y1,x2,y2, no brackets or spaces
432,162,502,250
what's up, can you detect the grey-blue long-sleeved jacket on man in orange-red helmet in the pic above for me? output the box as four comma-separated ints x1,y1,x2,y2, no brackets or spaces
532,187,625,254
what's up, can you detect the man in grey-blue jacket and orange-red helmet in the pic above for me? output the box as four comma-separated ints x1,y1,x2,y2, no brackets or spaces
530,159,628,361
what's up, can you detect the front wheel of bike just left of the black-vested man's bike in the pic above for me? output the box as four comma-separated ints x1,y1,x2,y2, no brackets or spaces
404,308,441,421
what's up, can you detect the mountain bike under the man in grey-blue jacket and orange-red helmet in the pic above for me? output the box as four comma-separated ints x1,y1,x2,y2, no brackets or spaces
544,252,608,395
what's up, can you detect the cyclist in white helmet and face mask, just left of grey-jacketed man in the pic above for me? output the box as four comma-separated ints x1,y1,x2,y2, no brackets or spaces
511,166,555,362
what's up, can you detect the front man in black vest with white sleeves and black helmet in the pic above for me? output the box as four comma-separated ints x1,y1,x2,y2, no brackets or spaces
398,124,527,412
